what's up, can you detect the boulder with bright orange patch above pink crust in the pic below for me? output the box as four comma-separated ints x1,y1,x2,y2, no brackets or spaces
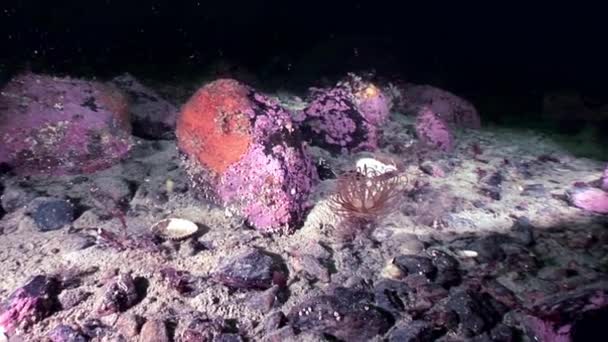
177,79,318,232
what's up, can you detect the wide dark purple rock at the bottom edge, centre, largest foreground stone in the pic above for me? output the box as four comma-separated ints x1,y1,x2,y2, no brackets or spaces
288,288,394,341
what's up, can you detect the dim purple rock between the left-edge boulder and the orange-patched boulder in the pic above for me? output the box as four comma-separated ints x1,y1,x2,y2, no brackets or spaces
112,73,178,139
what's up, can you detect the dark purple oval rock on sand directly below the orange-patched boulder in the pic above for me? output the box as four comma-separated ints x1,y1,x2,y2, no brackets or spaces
214,249,285,290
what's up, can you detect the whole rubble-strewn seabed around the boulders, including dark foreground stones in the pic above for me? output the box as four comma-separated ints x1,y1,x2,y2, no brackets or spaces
0,95,608,341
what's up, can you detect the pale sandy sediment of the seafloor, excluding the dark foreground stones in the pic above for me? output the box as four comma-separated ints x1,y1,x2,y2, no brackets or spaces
0,89,608,341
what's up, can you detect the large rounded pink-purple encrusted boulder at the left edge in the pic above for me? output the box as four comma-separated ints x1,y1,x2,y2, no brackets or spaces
0,73,131,175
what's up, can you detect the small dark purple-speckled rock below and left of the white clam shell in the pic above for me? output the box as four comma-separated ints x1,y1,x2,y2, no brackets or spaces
96,273,140,315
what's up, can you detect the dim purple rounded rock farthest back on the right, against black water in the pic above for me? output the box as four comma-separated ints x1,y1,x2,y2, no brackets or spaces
402,85,481,129
